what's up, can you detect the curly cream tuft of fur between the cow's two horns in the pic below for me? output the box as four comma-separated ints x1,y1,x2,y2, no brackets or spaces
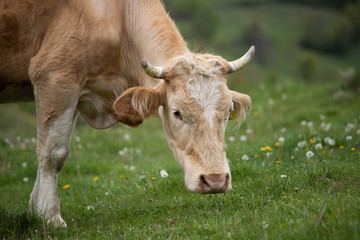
173,53,225,78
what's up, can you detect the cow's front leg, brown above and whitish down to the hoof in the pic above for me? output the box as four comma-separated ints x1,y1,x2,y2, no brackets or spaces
29,85,78,227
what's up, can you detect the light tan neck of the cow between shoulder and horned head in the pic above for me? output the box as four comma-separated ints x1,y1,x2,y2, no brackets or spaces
123,0,189,87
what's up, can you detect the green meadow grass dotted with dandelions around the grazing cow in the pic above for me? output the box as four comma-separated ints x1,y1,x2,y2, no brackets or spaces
0,77,360,239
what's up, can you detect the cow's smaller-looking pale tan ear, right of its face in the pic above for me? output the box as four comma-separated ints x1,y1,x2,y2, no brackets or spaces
229,91,251,124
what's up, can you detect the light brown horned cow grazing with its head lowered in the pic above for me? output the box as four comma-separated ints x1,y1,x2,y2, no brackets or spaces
0,0,254,227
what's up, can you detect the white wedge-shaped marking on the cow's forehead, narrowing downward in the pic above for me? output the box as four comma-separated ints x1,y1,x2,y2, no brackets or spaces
186,77,221,128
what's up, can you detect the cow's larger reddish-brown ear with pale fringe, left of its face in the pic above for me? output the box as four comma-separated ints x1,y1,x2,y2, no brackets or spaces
113,87,163,127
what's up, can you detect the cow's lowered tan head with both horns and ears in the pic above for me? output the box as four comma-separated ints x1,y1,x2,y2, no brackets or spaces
114,47,254,193
